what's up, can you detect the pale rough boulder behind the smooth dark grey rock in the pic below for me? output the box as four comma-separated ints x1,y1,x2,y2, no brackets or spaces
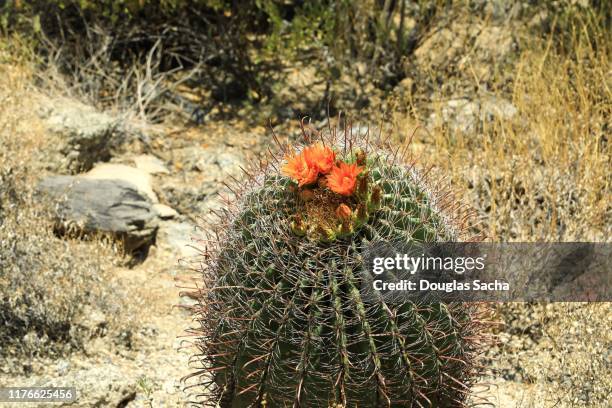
39,99,123,173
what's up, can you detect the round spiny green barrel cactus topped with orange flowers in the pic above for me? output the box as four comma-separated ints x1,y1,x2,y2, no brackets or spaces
189,122,490,408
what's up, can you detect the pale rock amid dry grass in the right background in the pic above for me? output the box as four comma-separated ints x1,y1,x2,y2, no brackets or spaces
429,96,518,133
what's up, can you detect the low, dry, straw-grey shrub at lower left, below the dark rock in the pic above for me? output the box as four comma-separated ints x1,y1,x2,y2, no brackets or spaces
0,167,129,370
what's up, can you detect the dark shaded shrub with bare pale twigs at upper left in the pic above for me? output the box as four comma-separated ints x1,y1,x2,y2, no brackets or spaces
4,0,280,120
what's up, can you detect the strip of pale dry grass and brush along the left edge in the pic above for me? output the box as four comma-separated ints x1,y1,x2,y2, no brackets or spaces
0,39,131,371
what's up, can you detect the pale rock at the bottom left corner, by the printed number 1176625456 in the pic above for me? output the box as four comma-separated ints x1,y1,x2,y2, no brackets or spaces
23,364,137,408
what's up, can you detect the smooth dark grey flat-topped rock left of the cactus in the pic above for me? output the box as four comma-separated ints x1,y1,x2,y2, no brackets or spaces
38,176,158,251
